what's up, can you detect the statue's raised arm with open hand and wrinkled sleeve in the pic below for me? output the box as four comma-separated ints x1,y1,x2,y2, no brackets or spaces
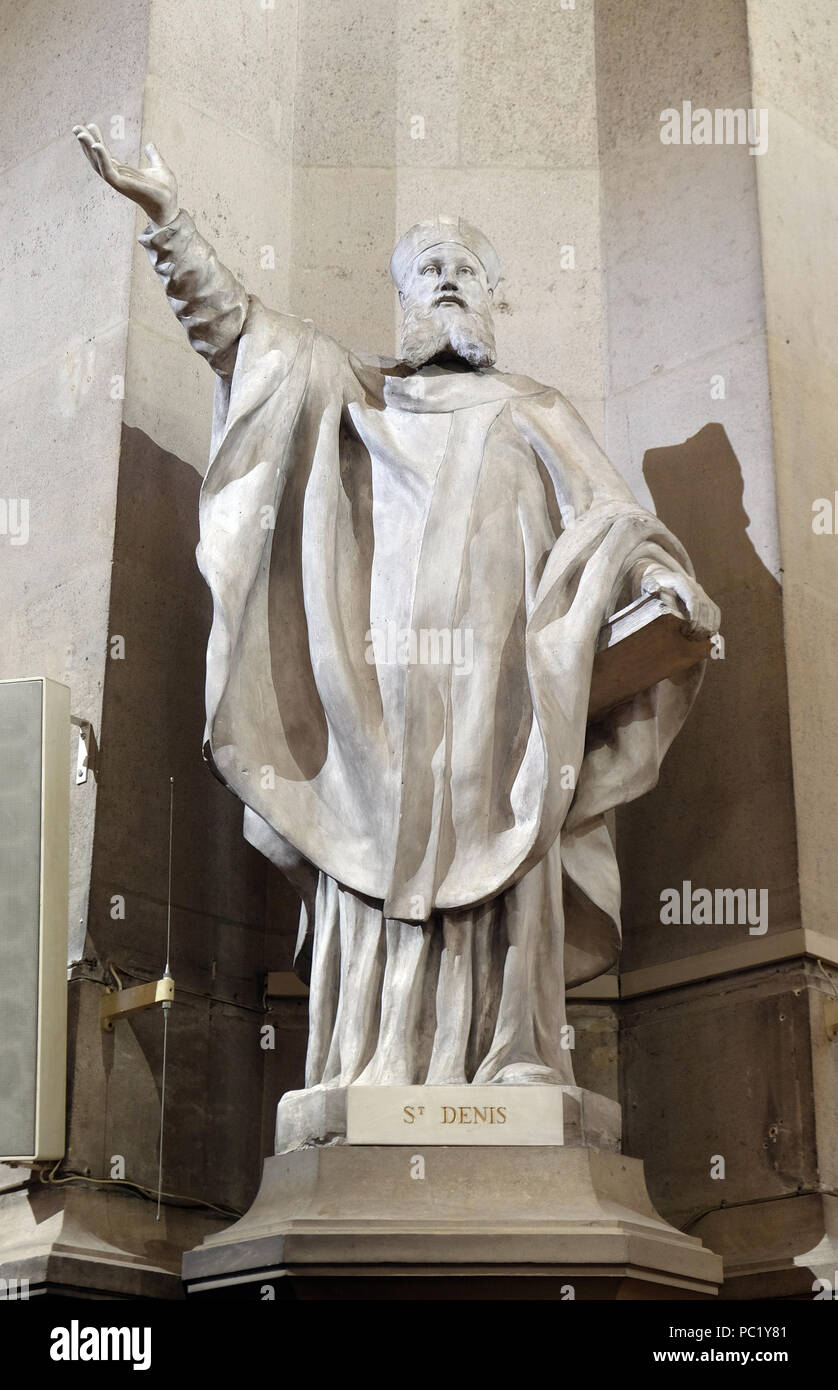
74,125,247,377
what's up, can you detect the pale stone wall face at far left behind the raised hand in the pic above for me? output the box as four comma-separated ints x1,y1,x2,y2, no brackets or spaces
0,0,146,978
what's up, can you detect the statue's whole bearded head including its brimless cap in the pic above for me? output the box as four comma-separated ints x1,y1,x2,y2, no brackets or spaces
391,217,500,367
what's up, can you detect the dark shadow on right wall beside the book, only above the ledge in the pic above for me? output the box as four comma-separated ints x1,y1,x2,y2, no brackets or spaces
617,424,799,972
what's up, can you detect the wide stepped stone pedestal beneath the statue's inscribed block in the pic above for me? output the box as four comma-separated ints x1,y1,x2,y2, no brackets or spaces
183,1144,721,1298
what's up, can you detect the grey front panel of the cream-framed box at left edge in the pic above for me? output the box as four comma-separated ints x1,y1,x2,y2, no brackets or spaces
0,681,43,1154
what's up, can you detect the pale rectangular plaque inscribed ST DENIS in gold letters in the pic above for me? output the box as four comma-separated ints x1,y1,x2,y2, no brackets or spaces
346,1086,564,1145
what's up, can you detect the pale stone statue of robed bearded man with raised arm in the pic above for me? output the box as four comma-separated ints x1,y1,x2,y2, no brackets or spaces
75,125,718,1138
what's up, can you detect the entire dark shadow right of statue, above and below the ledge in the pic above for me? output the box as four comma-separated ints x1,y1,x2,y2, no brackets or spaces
617,424,820,1278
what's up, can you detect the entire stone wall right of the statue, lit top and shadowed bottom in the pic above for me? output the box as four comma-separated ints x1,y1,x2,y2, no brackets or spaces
596,0,835,1297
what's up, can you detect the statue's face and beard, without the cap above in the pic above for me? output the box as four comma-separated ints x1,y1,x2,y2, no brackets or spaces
399,242,495,367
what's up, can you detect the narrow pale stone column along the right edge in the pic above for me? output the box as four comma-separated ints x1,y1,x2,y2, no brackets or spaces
748,0,838,1291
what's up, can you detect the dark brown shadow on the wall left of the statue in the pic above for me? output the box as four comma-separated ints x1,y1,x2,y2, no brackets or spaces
71,428,296,1209
